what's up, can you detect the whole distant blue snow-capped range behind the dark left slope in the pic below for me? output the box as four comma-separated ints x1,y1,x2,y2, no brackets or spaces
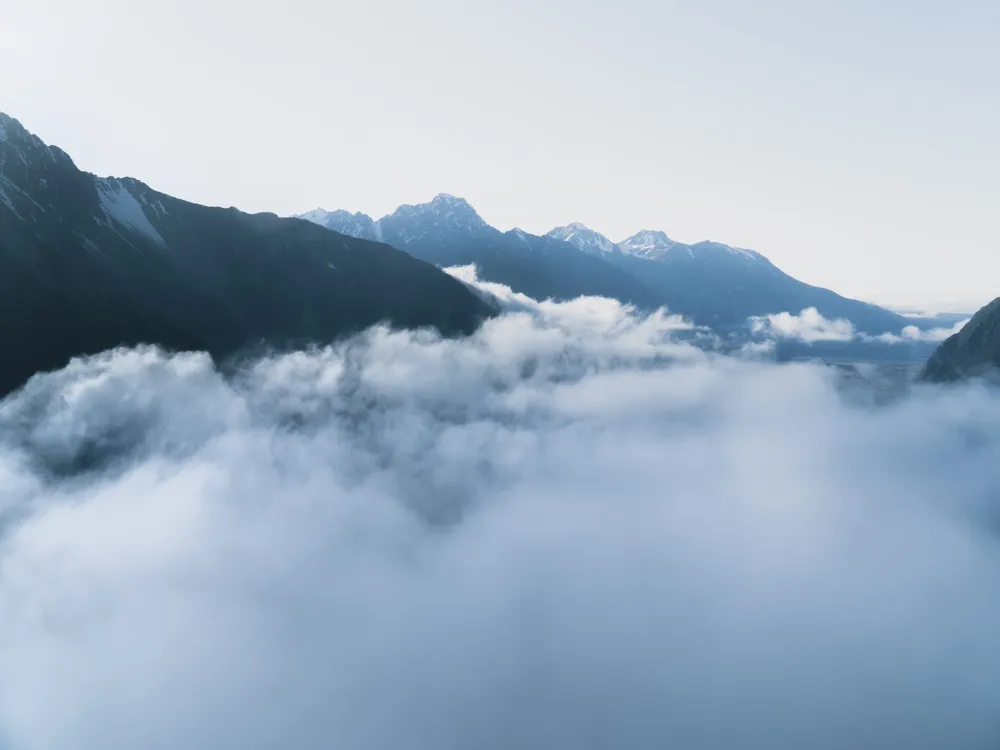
299,200,919,335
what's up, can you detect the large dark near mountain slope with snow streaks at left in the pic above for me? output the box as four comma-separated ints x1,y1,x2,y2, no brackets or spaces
0,115,494,394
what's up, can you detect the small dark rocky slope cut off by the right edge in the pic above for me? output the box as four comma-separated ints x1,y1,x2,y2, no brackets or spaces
921,297,1000,383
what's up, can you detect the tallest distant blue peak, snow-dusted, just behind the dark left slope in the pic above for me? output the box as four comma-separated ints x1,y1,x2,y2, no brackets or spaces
299,194,662,309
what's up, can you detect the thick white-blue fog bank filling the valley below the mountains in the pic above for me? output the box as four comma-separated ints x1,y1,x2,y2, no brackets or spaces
0,270,1000,750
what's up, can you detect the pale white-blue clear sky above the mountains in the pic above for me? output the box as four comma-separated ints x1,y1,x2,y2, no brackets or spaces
0,0,1000,309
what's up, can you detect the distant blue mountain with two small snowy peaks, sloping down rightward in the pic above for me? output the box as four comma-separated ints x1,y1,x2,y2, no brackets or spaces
549,224,914,335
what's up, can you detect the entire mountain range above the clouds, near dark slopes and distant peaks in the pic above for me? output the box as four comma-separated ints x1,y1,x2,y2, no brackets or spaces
0,113,988,396
